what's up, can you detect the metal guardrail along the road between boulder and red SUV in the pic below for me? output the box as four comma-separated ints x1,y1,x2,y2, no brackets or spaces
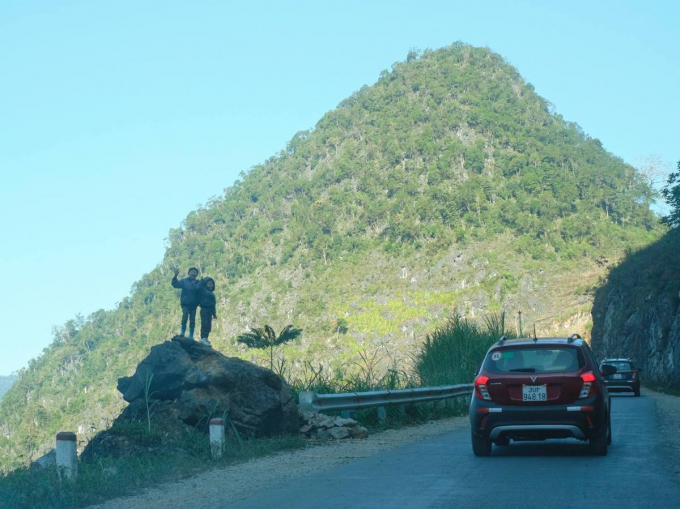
300,384,475,413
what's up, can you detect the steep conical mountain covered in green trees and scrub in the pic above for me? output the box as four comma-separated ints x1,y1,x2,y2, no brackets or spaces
0,44,660,468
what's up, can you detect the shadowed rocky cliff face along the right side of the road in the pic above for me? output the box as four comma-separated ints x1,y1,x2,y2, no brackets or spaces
592,231,680,389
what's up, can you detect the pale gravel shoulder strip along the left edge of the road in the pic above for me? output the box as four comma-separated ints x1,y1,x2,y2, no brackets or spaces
89,416,469,509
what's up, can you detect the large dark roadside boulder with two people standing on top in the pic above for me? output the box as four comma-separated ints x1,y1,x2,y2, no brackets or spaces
81,336,299,461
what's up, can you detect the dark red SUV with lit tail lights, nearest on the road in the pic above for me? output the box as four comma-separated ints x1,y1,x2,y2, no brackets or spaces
470,334,616,456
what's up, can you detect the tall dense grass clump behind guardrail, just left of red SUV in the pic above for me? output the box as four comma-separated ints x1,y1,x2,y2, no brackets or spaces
415,313,512,386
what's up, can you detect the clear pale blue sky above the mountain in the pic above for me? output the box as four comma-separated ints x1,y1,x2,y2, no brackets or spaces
0,0,680,375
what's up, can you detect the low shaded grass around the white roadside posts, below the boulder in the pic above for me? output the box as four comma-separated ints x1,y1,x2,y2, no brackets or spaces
0,423,306,509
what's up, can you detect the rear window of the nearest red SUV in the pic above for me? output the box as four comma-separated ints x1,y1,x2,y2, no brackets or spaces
484,347,585,373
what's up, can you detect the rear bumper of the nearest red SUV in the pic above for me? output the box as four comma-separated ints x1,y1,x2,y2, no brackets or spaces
470,396,606,440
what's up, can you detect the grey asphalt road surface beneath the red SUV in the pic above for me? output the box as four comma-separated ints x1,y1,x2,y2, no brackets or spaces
223,395,680,509
